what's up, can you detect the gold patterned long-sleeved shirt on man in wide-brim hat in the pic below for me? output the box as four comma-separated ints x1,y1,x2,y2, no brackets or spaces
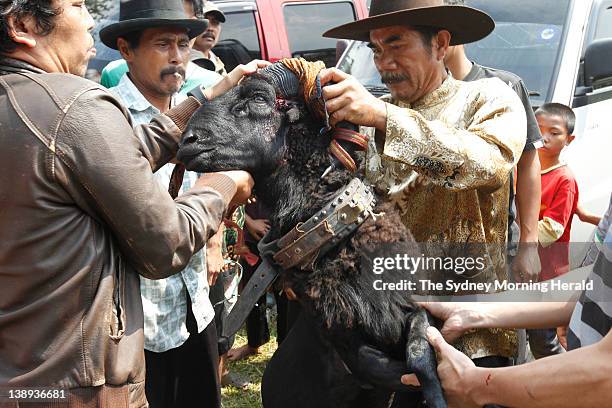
362,75,527,358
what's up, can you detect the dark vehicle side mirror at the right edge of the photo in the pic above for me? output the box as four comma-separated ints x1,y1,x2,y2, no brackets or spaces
584,38,612,89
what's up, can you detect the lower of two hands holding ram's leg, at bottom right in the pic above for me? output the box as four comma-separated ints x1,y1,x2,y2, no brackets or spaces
401,327,482,408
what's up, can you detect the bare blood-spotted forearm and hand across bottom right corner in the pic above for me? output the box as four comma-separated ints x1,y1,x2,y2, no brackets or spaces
428,329,612,408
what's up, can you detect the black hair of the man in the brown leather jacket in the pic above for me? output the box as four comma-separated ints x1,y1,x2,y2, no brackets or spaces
0,0,62,54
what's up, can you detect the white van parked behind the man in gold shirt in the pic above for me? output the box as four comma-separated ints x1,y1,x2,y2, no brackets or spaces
338,0,612,264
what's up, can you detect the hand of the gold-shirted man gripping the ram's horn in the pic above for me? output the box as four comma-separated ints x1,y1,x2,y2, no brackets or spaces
319,68,387,132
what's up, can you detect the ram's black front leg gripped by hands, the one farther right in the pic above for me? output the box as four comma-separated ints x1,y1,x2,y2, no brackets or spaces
406,309,447,408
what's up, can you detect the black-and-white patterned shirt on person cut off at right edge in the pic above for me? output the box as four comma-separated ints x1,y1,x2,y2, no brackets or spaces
567,193,612,349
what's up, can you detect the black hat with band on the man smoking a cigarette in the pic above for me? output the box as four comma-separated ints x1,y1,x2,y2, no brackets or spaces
100,0,208,50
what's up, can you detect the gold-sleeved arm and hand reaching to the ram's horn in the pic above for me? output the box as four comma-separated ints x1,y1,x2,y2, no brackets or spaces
321,70,526,190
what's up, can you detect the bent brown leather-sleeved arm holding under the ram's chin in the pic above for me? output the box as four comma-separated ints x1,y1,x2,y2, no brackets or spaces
55,90,246,279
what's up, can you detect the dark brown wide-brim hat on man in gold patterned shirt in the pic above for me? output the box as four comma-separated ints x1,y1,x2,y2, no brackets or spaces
323,0,495,45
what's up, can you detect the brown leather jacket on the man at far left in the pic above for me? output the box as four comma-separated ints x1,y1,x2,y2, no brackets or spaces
0,58,236,408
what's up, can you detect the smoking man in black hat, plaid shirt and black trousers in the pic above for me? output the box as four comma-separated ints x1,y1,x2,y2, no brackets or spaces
100,0,234,408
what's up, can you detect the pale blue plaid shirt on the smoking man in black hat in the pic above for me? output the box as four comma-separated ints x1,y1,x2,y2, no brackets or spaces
110,75,216,353
